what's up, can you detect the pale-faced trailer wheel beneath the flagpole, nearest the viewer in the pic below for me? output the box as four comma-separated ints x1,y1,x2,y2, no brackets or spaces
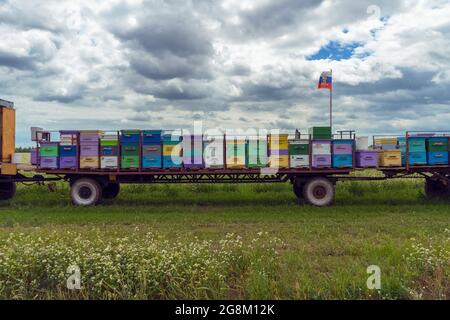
303,178,335,207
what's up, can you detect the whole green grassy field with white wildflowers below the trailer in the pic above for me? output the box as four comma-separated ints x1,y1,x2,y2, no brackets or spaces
0,179,450,299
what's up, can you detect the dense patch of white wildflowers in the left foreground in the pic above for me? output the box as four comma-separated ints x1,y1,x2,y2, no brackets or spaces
0,230,284,299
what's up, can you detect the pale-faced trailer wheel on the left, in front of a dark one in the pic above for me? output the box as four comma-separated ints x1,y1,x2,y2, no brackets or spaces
70,178,102,206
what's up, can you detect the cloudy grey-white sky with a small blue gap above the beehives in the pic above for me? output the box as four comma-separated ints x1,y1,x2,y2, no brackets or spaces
0,0,450,146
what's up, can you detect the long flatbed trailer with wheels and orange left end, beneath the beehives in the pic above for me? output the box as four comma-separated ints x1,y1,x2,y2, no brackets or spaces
0,100,450,206
